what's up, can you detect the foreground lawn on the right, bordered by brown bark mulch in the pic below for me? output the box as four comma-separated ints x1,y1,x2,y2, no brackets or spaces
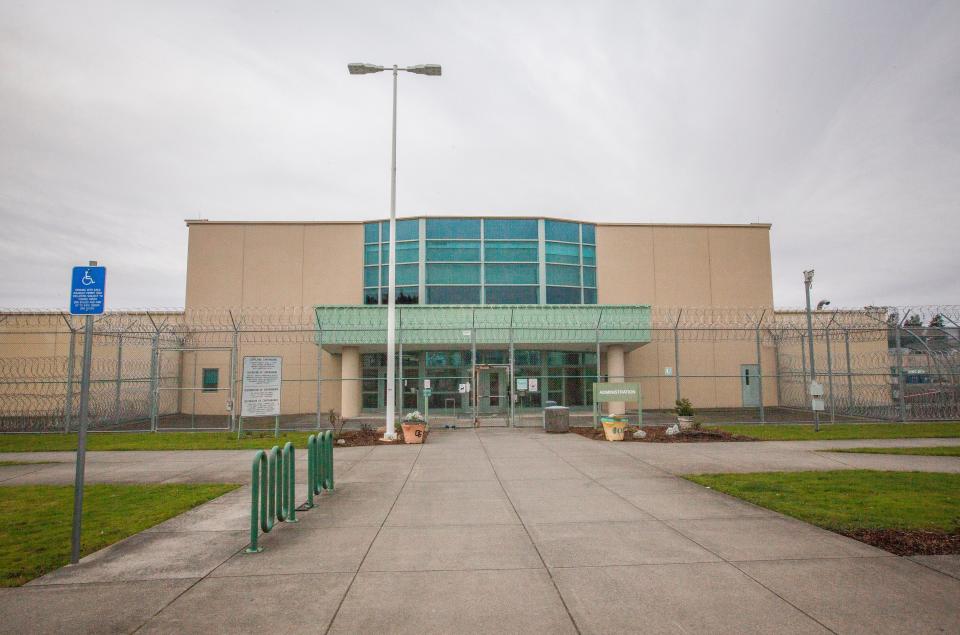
686,470,960,532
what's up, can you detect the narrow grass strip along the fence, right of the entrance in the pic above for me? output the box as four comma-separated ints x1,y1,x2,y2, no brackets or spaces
708,421,960,441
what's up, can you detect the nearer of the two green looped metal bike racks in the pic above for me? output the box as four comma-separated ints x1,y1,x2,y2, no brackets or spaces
247,441,297,553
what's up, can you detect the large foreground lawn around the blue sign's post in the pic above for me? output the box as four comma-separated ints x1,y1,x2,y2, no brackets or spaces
0,483,239,587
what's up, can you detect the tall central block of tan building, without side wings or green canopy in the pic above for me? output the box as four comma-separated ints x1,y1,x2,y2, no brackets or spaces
184,217,777,417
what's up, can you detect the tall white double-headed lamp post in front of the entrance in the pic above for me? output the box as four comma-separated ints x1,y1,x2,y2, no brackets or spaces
347,63,440,441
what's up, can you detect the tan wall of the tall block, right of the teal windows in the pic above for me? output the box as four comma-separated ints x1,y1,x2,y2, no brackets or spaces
597,225,776,409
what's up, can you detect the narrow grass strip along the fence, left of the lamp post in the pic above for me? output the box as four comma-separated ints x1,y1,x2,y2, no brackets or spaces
0,431,311,452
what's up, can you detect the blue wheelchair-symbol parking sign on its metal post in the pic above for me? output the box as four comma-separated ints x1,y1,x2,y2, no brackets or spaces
70,260,107,564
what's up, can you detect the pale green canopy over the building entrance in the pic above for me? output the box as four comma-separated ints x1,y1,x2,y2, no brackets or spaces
316,304,650,352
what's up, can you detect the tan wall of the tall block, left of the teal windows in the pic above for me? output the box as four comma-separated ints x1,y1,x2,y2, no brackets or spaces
184,223,363,414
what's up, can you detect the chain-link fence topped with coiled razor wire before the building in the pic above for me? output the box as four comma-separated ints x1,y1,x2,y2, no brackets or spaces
0,305,960,433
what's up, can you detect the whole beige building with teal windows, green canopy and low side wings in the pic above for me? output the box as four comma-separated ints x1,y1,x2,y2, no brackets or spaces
0,216,892,429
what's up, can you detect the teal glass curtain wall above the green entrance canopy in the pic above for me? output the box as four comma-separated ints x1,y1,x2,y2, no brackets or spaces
363,218,597,304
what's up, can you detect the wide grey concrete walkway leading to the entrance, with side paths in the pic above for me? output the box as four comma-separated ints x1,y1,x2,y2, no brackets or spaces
0,430,960,633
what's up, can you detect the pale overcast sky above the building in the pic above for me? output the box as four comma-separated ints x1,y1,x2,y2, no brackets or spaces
0,0,960,308
